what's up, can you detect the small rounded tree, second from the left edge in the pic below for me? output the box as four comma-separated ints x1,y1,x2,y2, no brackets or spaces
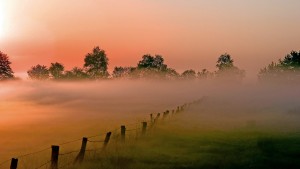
27,64,49,80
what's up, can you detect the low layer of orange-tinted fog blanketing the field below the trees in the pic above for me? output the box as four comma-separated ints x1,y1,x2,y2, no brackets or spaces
0,80,300,166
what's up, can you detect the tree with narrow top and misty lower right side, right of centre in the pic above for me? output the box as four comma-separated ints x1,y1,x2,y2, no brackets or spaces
216,53,245,81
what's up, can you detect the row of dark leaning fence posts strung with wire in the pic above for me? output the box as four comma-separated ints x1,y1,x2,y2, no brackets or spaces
0,98,204,169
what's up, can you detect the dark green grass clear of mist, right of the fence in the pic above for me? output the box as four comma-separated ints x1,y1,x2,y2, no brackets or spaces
69,127,300,169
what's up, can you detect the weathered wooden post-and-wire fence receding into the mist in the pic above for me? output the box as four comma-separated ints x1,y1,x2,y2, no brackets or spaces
0,98,203,169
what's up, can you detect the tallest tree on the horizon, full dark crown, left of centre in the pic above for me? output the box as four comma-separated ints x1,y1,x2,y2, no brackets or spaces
84,46,109,79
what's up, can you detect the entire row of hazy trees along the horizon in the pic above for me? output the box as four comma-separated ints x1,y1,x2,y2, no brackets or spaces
0,46,300,82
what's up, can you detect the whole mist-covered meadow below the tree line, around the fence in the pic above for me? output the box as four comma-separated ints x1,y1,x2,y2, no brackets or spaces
0,81,300,169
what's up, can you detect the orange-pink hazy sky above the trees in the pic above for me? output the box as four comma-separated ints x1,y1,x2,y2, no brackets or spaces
0,0,300,78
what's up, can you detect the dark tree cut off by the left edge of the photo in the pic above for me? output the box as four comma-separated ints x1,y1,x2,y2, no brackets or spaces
0,51,14,80
